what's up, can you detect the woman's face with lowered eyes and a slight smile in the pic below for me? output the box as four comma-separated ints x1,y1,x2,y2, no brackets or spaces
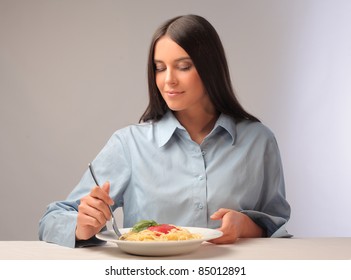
154,36,212,115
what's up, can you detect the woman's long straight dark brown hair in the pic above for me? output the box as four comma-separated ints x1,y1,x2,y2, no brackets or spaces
140,15,259,122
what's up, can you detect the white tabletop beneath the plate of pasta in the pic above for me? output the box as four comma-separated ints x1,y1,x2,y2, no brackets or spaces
0,237,351,260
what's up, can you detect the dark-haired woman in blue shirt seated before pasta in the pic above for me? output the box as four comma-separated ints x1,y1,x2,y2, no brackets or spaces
39,15,290,247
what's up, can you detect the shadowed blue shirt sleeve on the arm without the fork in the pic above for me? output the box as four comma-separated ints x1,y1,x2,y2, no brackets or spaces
241,136,292,237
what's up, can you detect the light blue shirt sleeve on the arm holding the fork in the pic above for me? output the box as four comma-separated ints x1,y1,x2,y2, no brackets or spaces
39,133,130,248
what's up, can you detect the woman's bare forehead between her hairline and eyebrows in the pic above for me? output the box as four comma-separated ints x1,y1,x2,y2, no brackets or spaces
154,36,190,61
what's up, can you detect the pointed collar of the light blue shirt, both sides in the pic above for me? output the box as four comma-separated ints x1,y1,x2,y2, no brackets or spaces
156,111,236,147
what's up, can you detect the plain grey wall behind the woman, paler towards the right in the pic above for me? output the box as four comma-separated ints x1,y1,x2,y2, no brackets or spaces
0,0,351,240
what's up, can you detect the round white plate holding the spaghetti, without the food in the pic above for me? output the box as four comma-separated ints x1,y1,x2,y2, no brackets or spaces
96,227,223,256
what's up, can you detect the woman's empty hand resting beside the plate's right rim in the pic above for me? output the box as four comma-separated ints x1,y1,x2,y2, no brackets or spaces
210,208,263,244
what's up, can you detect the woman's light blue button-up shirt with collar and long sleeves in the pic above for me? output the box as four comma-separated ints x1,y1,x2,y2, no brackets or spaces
39,112,291,247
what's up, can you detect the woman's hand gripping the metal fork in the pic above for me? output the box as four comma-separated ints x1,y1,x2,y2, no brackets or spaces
76,182,114,240
